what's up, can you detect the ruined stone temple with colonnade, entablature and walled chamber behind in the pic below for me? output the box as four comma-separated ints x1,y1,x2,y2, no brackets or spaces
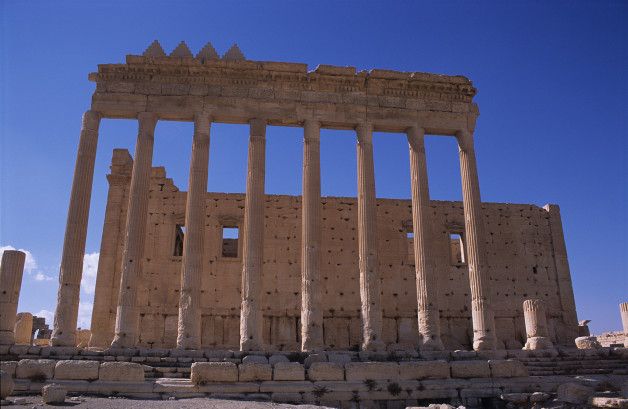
51,42,578,352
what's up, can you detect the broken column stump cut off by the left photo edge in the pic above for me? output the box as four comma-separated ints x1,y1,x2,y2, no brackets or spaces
0,250,26,345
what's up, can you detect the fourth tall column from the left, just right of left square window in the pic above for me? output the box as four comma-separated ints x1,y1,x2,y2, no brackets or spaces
240,118,266,351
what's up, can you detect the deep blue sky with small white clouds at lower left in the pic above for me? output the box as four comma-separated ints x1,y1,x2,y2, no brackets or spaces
0,0,628,333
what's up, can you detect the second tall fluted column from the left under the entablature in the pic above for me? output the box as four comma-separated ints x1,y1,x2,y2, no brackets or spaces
111,112,157,348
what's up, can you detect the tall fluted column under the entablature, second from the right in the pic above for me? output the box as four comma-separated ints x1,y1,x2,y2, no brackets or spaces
407,126,444,351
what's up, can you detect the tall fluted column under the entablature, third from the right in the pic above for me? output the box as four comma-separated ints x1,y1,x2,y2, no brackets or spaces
356,123,386,351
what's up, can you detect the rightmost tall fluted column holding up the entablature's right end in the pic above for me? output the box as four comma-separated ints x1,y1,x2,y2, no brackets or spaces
456,130,497,350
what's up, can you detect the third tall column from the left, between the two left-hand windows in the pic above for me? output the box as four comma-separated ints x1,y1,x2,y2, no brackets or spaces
177,113,210,349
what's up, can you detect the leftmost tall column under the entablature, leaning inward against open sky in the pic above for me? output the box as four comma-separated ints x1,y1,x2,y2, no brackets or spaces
50,111,101,346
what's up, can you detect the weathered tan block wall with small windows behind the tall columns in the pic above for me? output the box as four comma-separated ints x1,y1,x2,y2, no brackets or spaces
92,150,577,350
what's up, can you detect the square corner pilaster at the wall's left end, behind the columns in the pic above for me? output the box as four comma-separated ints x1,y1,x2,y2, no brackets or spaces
89,149,133,349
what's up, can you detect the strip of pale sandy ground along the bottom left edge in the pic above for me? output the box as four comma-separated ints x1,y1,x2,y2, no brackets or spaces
2,395,331,409
